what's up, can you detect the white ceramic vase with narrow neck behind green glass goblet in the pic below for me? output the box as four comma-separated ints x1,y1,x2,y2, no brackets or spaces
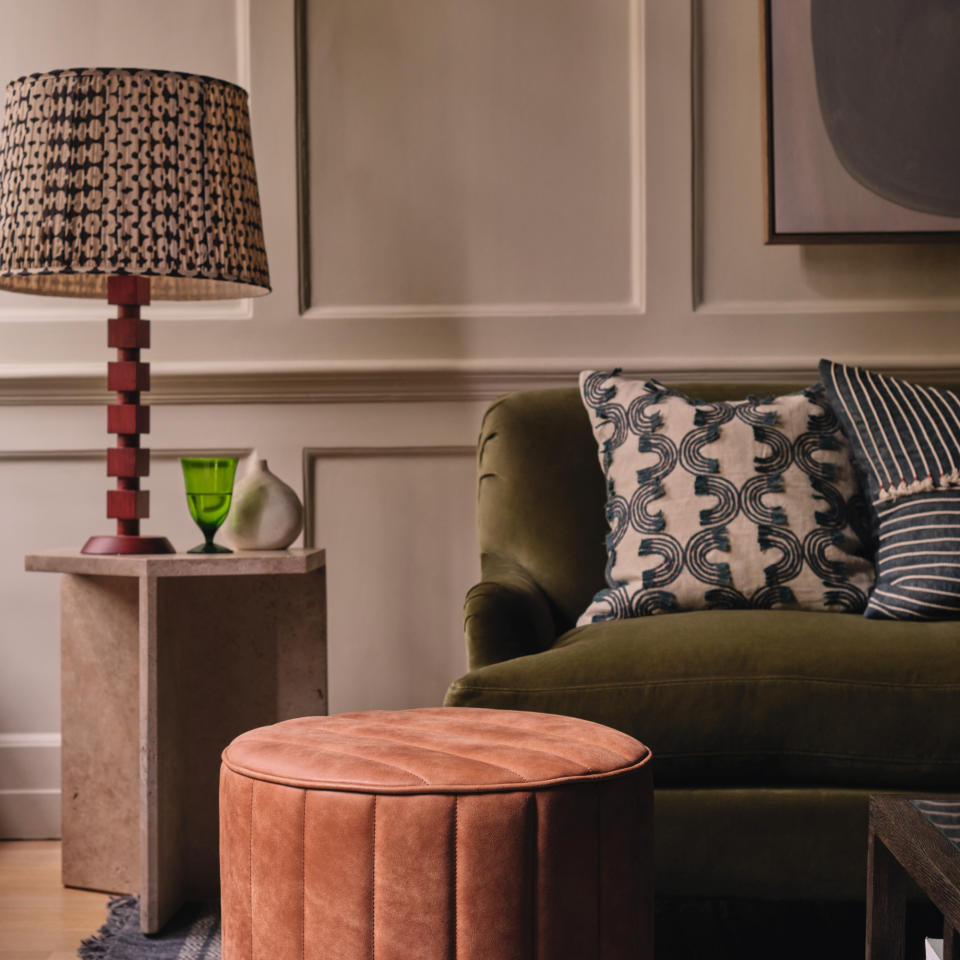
224,450,303,550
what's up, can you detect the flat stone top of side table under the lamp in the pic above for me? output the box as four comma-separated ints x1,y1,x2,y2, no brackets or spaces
24,547,326,577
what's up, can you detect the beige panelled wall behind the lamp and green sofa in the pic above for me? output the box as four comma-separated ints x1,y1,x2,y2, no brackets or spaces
0,0,960,835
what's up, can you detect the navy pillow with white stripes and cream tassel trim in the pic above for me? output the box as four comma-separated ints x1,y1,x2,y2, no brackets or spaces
820,360,960,620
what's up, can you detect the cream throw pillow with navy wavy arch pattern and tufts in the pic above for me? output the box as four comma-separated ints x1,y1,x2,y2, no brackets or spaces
578,371,873,625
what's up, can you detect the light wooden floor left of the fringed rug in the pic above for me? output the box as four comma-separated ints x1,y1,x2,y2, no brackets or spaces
0,840,109,960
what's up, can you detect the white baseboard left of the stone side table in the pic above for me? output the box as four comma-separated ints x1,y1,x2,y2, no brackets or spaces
0,733,60,840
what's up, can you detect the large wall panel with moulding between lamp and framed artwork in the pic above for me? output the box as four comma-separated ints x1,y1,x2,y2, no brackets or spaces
291,0,646,321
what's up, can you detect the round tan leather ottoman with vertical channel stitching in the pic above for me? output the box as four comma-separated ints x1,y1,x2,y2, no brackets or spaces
220,707,653,960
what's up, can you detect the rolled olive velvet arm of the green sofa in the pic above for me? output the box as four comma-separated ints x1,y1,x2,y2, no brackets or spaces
463,555,556,670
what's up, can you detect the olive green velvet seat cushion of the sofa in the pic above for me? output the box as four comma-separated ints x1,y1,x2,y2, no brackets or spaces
446,610,960,791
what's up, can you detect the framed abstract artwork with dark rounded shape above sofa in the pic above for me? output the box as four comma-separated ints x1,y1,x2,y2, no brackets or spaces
760,0,960,243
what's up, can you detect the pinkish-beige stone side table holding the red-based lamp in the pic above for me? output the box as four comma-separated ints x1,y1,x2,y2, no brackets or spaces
26,549,327,933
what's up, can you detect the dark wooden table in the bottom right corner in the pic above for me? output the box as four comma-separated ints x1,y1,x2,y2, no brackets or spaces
866,794,960,960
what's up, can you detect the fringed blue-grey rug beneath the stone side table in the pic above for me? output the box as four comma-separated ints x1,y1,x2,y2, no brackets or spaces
77,897,220,960
